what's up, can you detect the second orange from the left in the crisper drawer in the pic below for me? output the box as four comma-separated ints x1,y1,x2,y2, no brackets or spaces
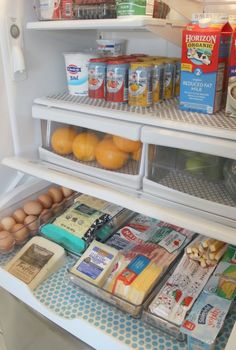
72,132,99,162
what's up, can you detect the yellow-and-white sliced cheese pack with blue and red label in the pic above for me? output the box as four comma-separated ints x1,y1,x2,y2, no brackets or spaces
112,255,163,305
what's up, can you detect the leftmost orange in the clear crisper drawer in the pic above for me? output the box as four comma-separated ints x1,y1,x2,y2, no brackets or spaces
51,127,77,155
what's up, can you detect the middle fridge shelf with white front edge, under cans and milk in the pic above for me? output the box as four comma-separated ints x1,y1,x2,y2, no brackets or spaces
34,91,236,141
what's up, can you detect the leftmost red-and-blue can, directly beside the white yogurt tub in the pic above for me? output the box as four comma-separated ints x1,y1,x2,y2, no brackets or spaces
88,58,107,99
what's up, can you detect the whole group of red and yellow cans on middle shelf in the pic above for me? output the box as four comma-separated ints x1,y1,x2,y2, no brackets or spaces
88,54,180,107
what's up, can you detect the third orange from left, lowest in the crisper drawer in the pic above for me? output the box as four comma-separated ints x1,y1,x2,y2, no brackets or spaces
96,138,129,170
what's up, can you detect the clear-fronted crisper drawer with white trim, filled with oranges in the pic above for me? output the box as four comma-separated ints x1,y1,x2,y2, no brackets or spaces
33,106,144,189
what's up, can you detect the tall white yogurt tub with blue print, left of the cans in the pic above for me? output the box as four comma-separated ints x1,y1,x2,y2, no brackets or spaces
64,52,94,96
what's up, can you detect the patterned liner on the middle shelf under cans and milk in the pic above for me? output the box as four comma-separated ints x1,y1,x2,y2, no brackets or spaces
43,91,236,131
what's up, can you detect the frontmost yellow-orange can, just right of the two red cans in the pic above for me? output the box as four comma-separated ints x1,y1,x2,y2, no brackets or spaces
128,62,153,107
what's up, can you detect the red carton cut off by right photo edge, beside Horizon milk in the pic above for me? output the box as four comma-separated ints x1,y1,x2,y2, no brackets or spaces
225,20,236,117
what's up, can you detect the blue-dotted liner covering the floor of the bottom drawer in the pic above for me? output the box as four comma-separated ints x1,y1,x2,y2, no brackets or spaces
0,252,236,350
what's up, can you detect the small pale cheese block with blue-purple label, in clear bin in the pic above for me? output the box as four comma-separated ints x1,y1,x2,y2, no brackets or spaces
70,241,119,287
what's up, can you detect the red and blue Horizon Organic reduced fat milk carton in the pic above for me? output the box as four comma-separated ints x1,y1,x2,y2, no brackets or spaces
180,19,232,114
